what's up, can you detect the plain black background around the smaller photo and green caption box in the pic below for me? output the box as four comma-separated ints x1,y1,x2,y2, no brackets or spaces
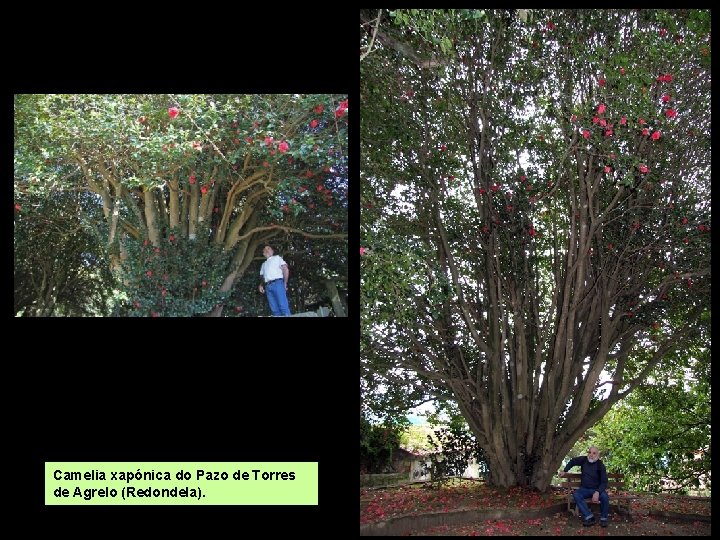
9,5,359,536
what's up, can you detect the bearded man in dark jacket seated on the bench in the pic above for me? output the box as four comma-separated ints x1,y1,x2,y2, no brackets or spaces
559,446,610,527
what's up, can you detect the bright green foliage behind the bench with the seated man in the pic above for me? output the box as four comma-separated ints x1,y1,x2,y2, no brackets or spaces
592,347,711,493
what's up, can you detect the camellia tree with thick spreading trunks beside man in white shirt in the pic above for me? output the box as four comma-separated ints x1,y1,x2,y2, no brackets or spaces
15,94,348,316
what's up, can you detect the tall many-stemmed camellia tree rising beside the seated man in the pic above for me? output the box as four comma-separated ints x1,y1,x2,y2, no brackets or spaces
360,10,711,490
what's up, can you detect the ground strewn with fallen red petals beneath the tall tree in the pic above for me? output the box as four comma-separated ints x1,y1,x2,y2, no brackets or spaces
360,481,711,536
